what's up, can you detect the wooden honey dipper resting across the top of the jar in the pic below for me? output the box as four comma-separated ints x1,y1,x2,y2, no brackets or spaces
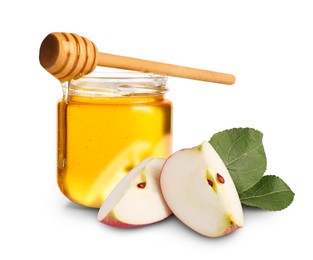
39,32,236,84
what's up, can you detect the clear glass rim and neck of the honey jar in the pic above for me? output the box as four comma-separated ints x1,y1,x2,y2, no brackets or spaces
68,72,168,97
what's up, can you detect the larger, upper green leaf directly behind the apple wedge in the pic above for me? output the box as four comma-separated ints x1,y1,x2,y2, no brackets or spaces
209,128,266,194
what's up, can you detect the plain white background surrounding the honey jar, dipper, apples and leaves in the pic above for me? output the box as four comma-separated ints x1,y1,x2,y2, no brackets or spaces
0,0,313,259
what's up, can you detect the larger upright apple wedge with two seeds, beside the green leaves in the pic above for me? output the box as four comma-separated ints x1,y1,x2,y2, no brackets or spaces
160,142,244,237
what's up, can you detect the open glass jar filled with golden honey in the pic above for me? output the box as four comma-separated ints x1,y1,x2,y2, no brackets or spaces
57,72,172,208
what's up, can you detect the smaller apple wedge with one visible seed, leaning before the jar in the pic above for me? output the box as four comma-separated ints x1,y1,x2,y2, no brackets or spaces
97,157,172,228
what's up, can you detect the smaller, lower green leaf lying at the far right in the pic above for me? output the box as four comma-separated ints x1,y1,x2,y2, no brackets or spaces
240,175,295,211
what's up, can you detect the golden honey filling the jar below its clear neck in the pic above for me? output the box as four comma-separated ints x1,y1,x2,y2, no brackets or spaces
58,96,171,208
